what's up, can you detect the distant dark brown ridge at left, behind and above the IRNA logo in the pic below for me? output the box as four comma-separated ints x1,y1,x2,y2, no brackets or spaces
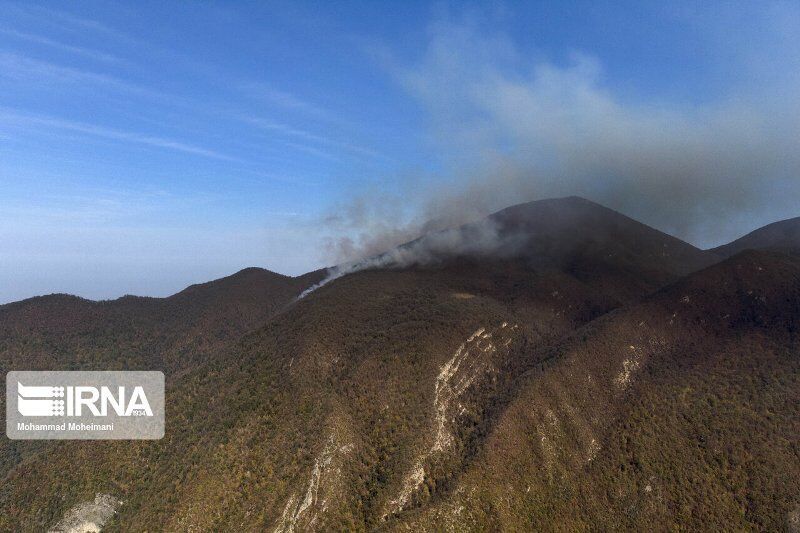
0,268,322,494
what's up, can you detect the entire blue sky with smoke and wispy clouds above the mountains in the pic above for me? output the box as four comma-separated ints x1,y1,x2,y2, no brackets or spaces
0,1,800,303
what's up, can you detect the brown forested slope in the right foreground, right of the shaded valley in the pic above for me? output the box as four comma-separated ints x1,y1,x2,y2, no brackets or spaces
398,252,800,531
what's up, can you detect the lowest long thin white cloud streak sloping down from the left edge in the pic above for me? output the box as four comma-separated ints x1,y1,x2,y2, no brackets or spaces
0,107,240,161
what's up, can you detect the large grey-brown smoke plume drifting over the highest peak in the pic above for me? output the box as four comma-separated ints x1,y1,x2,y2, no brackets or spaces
327,5,800,269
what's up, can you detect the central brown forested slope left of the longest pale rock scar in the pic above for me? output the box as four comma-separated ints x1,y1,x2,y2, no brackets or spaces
0,256,648,531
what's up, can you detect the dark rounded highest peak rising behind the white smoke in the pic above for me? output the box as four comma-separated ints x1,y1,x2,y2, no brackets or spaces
378,196,719,300
